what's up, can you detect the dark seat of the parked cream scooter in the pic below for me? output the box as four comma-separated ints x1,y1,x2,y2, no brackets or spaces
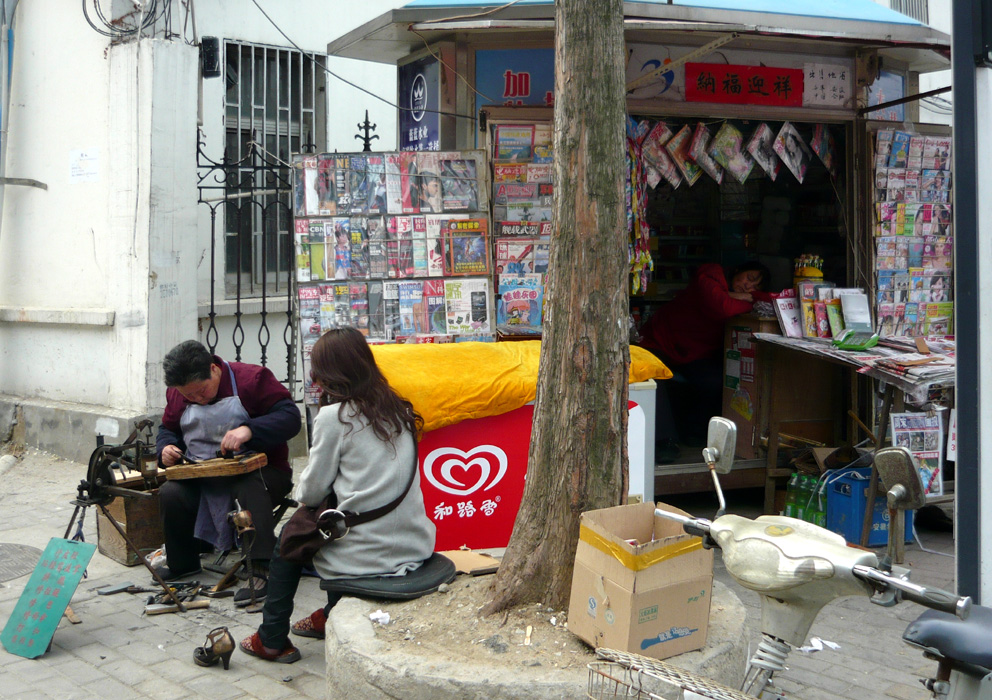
902,605,992,673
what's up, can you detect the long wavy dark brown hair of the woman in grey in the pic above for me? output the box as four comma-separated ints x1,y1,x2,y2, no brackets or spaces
310,328,423,442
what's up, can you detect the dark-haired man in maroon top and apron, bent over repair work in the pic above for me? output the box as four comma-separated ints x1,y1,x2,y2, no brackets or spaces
156,340,300,605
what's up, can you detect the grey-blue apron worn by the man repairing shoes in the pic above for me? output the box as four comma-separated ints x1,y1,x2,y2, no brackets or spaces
179,361,250,550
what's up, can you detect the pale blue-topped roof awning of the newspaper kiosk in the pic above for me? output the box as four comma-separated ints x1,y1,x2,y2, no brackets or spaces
327,0,950,73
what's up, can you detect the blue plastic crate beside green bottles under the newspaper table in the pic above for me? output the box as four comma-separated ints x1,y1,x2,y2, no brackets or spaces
827,467,913,547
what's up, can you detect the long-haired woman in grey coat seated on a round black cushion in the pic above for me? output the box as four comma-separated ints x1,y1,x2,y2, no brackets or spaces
240,328,435,663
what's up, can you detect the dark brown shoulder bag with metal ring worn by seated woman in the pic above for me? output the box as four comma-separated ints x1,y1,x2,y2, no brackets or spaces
279,442,419,564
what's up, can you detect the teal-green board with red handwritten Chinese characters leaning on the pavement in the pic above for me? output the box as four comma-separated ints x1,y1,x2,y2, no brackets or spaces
0,537,96,659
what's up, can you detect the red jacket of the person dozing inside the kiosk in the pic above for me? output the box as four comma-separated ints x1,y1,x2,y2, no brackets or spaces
641,263,753,365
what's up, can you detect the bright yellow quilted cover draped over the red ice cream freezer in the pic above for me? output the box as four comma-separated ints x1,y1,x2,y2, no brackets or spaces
372,340,672,431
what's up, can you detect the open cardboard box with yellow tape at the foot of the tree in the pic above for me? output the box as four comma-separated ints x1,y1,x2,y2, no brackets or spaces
568,503,713,659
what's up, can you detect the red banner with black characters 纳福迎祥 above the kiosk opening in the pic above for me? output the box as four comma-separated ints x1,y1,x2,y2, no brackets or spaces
685,63,803,107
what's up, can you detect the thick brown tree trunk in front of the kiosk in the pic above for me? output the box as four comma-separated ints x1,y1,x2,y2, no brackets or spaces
484,0,630,614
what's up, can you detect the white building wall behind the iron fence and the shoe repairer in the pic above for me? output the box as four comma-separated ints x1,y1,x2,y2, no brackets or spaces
0,0,402,412
